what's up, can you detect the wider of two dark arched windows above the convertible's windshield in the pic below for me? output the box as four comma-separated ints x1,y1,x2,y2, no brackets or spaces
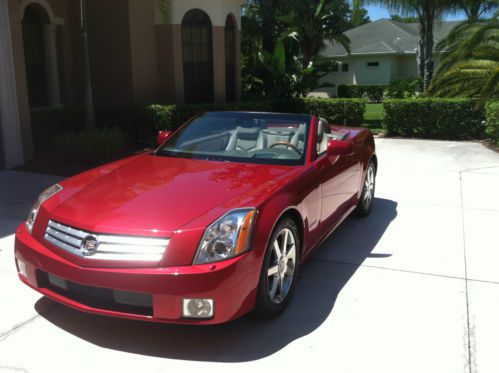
182,9,213,104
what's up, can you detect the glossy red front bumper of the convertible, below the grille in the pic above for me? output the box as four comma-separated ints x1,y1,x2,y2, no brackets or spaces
15,224,263,324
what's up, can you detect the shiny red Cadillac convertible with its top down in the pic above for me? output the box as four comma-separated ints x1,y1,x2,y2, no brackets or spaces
15,112,378,324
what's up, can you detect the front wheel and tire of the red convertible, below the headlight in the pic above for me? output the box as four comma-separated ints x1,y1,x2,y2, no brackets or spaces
255,218,301,318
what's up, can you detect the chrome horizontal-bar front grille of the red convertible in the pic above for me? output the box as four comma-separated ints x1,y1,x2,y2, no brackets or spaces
44,220,170,261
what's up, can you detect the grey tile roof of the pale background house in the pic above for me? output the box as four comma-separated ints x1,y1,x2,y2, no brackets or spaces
322,19,460,57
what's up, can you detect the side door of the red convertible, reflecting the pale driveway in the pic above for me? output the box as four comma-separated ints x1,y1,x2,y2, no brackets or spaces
315,119,360,234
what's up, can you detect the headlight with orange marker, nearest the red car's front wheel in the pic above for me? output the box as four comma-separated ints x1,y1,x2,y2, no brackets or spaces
193,208,255,264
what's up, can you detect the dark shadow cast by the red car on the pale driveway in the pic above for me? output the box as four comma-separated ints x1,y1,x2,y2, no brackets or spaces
35,199,397,362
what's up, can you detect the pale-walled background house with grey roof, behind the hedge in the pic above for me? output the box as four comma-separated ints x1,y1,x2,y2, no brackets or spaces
315,19,459,96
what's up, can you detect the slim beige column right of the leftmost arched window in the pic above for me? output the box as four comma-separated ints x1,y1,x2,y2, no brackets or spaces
43,24,62,107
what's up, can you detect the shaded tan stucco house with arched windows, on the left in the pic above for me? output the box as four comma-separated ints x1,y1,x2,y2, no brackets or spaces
0,0,243,169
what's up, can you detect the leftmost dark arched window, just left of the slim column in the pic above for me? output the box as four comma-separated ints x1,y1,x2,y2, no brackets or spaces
22,4,48,107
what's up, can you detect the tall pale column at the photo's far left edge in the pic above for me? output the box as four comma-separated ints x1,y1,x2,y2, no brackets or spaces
0,0,24,169
